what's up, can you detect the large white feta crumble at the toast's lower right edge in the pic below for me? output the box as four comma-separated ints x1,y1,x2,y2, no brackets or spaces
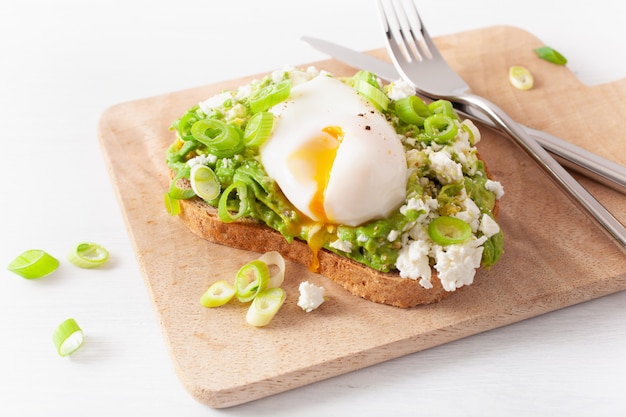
434,236,487,291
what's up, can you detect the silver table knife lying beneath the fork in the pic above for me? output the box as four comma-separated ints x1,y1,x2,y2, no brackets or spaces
301,36,626,194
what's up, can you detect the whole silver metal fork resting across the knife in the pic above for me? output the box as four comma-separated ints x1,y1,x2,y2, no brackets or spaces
378,0,626,253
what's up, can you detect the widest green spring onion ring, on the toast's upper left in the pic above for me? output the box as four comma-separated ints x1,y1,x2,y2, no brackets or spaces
191,119,243,158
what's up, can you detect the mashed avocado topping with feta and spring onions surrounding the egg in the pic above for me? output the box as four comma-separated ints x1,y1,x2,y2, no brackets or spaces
166,68,503,291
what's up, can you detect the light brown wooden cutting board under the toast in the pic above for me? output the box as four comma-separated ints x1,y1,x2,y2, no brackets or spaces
99,27,626,408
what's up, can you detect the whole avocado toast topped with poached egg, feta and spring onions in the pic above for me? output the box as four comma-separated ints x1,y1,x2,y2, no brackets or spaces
167,68,503,307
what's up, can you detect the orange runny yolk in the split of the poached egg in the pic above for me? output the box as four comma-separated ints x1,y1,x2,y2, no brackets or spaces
287,126,343,223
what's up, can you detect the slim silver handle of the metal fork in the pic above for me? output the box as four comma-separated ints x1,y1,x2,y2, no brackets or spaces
451,94,626,253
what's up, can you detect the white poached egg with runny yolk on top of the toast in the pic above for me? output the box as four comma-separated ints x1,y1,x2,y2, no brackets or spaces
260,75,407,226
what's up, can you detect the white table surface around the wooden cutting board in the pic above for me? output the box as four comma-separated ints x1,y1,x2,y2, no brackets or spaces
0,0,626,417
